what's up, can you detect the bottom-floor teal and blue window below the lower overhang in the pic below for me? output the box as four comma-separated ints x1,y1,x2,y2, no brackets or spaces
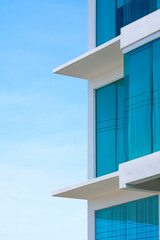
95,196,159,240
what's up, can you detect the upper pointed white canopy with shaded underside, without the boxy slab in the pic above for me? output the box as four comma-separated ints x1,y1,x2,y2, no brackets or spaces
53,36,123,80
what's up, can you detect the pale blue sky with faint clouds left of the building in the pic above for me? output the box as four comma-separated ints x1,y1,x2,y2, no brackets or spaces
0,0,87,240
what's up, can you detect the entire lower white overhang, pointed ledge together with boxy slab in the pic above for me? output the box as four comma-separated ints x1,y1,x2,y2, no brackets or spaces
52,152,160,200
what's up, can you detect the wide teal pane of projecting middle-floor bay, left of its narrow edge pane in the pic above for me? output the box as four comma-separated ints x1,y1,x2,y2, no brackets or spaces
125,45,152,161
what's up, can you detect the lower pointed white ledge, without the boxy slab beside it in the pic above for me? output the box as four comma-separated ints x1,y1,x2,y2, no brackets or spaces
52,172,119,200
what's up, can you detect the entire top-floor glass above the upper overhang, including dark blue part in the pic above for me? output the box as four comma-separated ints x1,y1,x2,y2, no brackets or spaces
96,0,160,46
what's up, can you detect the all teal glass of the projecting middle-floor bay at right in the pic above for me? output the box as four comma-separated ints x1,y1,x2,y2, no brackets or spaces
124,39,160,161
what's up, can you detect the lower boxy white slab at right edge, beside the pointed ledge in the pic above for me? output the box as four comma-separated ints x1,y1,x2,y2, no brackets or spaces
119,152,160,191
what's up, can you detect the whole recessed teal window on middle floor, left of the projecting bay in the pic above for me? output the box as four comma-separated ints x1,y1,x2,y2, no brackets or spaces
96,79,124,177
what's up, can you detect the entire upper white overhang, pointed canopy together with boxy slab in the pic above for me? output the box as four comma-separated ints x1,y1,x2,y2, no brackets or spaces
53,9,160,80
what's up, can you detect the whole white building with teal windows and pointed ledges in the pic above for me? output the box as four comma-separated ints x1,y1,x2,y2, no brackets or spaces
53,0,160,240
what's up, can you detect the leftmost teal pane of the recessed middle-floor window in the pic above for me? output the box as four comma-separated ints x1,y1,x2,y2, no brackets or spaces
96,84,116,177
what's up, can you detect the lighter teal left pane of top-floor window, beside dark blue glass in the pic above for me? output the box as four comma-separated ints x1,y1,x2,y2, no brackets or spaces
96,0,116,46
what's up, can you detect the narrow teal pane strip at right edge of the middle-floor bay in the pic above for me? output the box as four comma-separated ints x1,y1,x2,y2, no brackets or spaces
153,39,160,152
